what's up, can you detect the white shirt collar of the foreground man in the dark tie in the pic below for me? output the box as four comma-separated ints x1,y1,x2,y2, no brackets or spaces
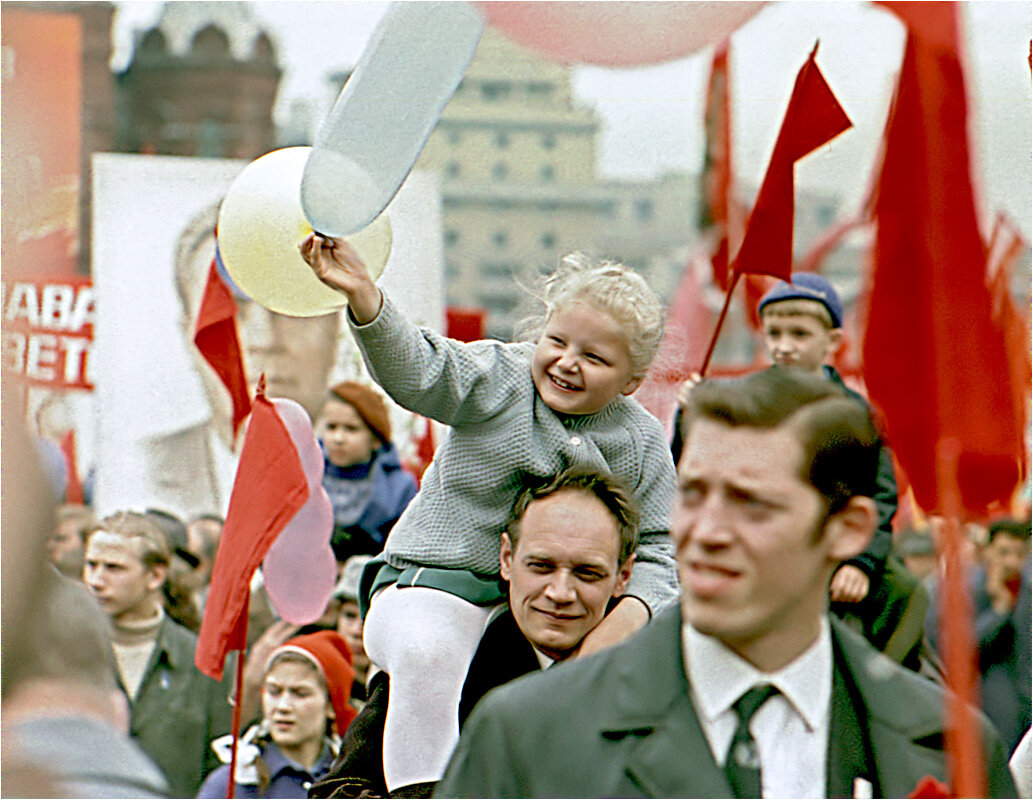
682,618,833,731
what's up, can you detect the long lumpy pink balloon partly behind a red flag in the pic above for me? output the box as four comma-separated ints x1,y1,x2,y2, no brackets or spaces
261,398,337,625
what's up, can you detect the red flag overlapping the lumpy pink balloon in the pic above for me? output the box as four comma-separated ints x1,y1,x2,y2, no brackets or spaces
194,384,309,680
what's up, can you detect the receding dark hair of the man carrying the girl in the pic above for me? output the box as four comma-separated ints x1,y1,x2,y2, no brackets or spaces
506,467,638,564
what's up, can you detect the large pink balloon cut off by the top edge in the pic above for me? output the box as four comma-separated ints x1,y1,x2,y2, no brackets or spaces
475,0,763,67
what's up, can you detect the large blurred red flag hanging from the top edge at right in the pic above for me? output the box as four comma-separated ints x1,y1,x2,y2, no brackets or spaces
864,2,1024,518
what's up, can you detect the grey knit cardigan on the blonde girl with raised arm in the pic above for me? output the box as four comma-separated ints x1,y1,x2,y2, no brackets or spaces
351,297,678,614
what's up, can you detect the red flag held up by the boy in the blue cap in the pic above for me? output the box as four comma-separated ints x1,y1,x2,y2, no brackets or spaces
731,44,852,281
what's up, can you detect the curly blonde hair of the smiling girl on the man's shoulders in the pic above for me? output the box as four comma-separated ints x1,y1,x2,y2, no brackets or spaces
517,252,664,378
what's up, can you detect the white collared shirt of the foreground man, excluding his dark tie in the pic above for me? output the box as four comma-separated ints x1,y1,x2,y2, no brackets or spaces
682,619,833,798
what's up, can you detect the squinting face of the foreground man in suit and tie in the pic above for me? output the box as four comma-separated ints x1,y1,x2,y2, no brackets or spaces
671,419,864,670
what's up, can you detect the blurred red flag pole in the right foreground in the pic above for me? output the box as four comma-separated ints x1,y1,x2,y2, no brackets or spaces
936,437,987,797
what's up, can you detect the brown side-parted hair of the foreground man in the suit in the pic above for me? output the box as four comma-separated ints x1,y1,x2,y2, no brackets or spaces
683,366,879,514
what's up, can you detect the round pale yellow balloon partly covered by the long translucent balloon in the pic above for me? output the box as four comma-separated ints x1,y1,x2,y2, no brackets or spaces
216,147,390,316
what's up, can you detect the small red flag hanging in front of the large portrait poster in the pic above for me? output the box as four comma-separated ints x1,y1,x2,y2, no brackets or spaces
194,259,251,436
